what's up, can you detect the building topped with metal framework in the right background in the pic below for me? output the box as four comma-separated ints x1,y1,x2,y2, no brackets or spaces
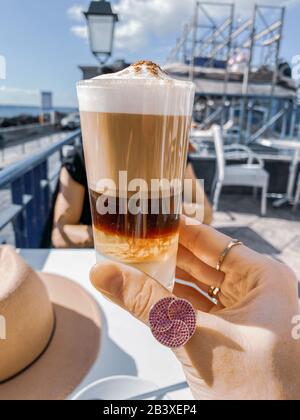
164,0,300,143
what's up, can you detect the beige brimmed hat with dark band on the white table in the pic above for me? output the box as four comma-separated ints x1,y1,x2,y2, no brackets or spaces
0,246,101,400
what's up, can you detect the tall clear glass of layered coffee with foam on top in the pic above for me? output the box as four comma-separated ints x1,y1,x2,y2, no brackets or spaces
77,61,195,290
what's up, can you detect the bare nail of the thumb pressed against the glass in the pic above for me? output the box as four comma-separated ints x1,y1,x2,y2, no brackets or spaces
90,263,123,296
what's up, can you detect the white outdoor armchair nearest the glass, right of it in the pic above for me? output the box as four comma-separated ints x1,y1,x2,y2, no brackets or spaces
212,125,270,216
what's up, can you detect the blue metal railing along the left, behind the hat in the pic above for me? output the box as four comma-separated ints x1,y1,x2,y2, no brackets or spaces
0,130,81,248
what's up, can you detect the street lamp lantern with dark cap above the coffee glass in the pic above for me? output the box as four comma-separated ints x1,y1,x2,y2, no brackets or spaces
84,0,119,64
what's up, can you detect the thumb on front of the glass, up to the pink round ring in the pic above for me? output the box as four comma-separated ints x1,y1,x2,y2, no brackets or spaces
90,262,173,324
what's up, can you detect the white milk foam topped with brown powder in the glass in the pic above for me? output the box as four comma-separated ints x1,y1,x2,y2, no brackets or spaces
77,61,195,116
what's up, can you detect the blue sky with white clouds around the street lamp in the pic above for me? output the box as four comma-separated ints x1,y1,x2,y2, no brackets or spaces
0,0,300,106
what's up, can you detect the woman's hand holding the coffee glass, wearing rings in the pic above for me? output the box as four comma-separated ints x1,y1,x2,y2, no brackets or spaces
91,218,300,400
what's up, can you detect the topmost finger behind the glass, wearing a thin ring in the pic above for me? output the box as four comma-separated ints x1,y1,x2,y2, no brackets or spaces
179,216,257,274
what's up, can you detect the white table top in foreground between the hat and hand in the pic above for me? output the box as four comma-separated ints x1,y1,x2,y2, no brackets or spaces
20,250,192,400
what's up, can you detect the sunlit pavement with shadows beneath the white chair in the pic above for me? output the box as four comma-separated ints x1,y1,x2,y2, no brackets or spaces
214,195,300,281
